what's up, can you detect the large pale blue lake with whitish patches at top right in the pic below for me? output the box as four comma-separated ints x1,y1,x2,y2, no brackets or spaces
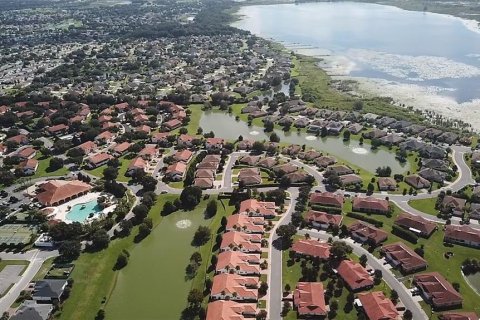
233,2,480,104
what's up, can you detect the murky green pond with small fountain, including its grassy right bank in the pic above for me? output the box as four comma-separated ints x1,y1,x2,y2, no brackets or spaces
106,201,233,320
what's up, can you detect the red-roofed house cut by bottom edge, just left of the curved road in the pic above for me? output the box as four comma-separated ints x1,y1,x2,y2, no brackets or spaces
358,291,401,320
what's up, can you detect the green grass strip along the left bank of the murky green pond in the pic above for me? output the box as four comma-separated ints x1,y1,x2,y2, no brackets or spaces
56,195,176,320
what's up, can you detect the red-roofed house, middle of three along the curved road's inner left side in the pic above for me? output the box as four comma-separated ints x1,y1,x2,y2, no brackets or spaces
337,260,374,292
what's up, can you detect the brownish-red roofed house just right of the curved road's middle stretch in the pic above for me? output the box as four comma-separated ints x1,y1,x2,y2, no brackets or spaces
382,242,427,274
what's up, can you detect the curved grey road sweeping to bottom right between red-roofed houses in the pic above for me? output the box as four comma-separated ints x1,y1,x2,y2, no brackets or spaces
298,229,428,320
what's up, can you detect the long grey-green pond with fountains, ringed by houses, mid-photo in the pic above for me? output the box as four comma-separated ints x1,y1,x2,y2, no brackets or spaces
200,112,410,173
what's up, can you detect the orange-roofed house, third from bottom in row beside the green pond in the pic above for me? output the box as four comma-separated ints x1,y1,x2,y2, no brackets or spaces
215,251,260,276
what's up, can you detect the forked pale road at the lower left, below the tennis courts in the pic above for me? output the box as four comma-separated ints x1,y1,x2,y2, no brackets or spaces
0,249,58,314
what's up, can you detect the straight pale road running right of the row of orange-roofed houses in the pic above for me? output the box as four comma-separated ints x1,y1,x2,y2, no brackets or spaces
268,188,299,320
